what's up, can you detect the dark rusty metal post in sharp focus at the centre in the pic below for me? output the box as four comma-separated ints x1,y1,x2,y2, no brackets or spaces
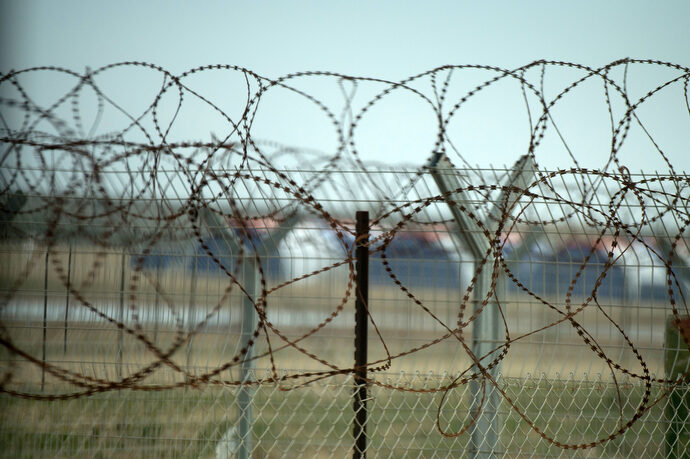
352,211,369,459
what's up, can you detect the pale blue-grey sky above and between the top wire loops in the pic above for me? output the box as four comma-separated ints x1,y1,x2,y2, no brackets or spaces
0,0,690,169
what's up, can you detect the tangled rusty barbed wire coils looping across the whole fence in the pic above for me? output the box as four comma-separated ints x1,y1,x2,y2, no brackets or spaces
0,59,690,449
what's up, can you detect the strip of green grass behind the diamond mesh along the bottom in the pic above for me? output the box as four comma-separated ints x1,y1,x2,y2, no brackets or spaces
0,375,676,458
